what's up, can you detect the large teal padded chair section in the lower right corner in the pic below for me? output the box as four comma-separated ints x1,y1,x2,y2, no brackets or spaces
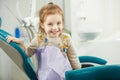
65,64,120,80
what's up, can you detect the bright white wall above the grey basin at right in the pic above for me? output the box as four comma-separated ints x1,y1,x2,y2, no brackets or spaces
71,0,120,39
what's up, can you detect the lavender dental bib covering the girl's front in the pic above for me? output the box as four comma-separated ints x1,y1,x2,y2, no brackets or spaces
36,46,72,80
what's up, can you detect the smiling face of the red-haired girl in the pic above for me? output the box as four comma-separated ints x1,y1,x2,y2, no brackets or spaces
42,14,63,38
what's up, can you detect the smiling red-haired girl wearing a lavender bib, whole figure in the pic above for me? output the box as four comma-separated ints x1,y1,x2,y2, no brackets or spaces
7,3,81,80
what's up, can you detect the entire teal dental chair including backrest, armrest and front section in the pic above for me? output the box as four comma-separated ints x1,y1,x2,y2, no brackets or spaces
0,29,114,80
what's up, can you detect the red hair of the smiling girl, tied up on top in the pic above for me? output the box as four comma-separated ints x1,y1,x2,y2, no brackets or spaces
38,2,64,33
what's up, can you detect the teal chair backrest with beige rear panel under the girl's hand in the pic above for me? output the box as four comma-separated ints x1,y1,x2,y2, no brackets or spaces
0,29,37,80
